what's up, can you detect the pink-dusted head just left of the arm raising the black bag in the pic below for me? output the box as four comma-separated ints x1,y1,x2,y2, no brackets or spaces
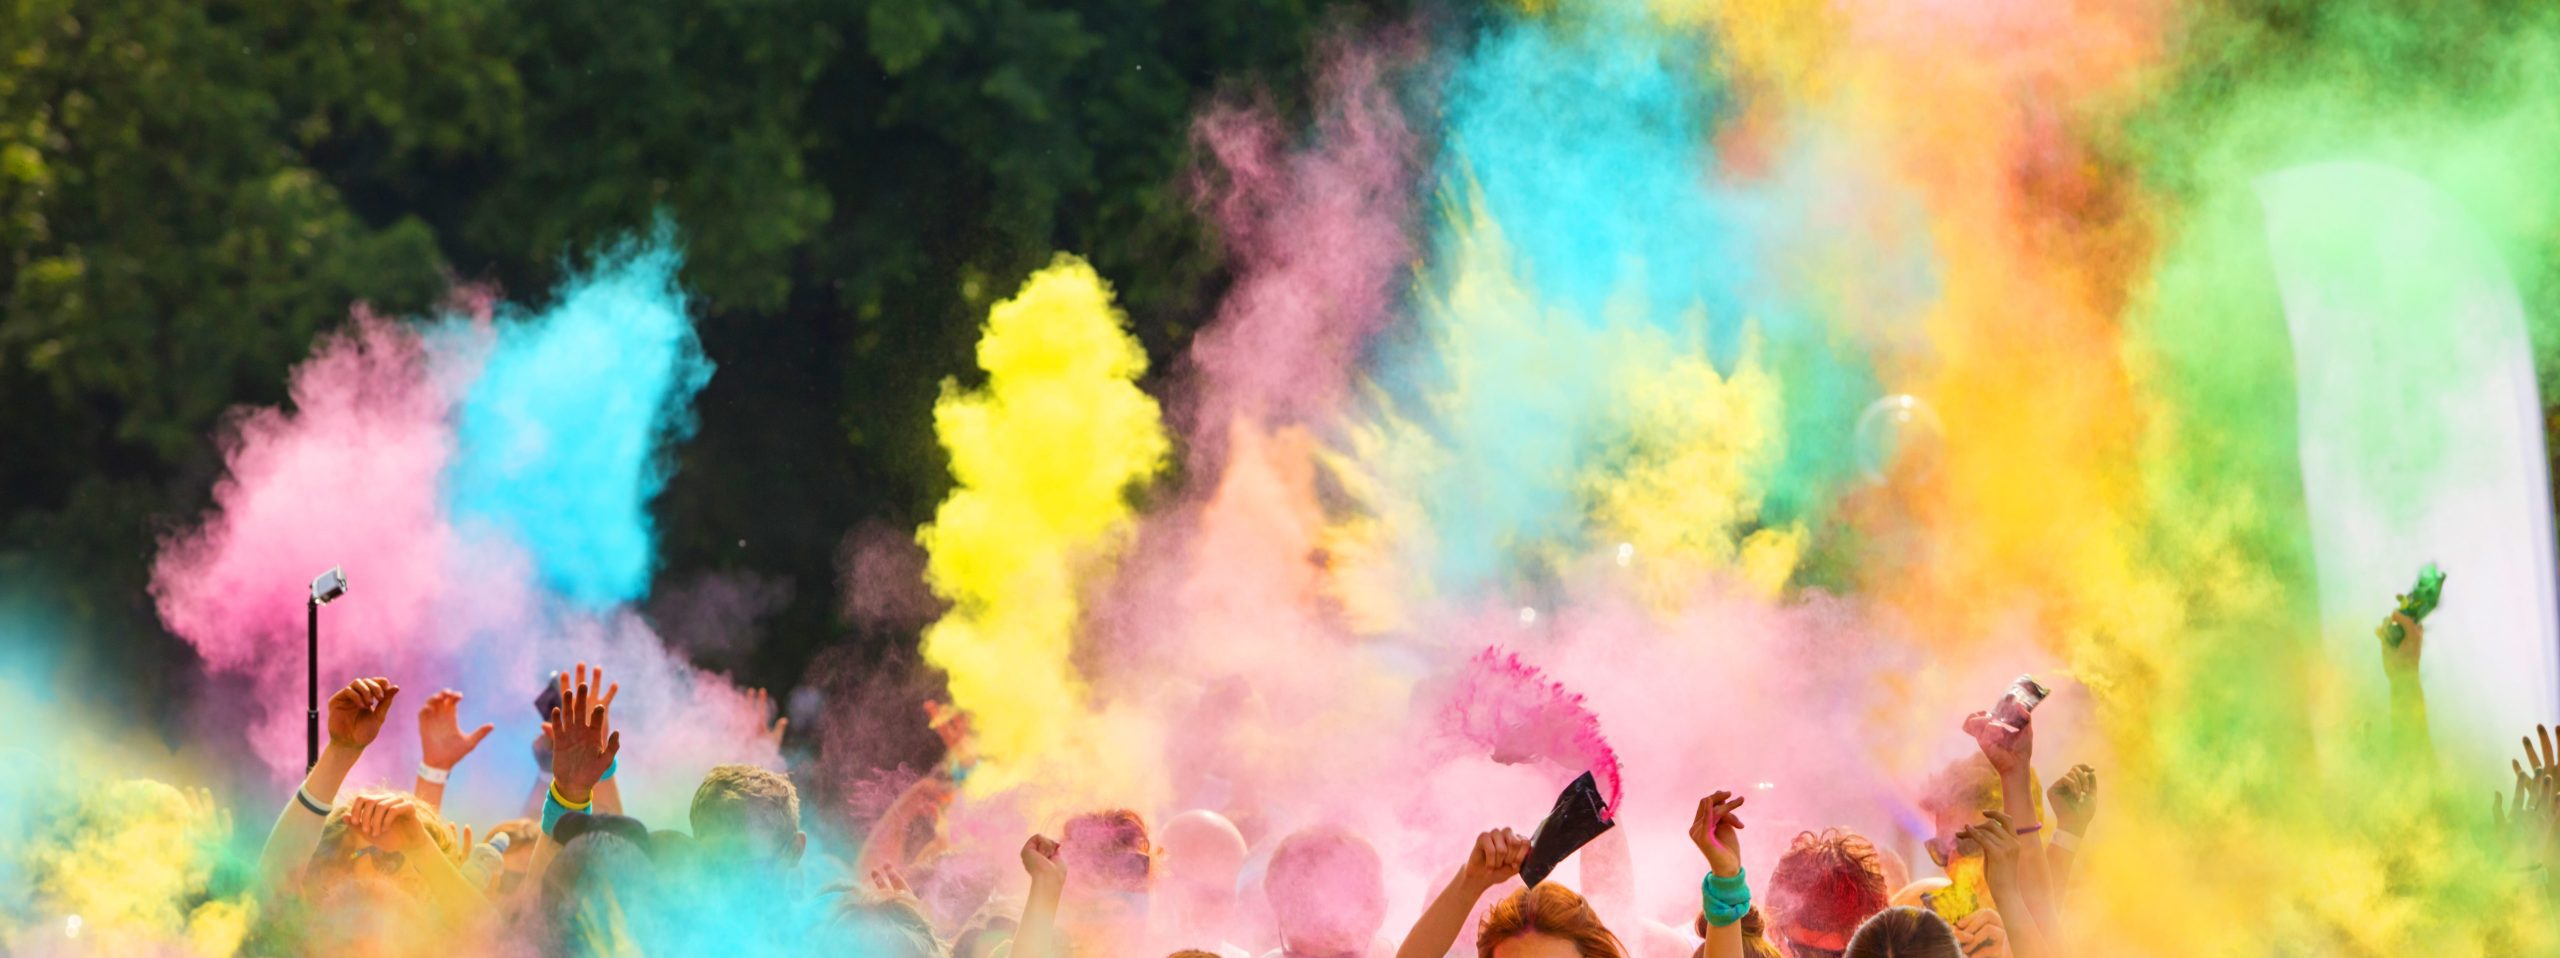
1262,825,1388,958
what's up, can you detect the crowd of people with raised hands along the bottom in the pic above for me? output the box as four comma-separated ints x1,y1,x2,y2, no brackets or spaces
215,617,2555,958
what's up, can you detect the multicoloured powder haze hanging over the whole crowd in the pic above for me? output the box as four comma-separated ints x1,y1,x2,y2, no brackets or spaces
15,0,2560,955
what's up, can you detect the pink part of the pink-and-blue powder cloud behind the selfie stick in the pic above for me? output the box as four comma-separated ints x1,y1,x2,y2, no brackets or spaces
151,313,456,768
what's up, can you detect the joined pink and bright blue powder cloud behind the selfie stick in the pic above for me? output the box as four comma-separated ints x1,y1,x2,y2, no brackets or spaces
154,239,778,815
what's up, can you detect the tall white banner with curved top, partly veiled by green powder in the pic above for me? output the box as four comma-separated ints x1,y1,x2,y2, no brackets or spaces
2255,161,2560,747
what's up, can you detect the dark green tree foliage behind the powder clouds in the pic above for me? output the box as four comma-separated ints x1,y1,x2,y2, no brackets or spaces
0,0,1385,696
